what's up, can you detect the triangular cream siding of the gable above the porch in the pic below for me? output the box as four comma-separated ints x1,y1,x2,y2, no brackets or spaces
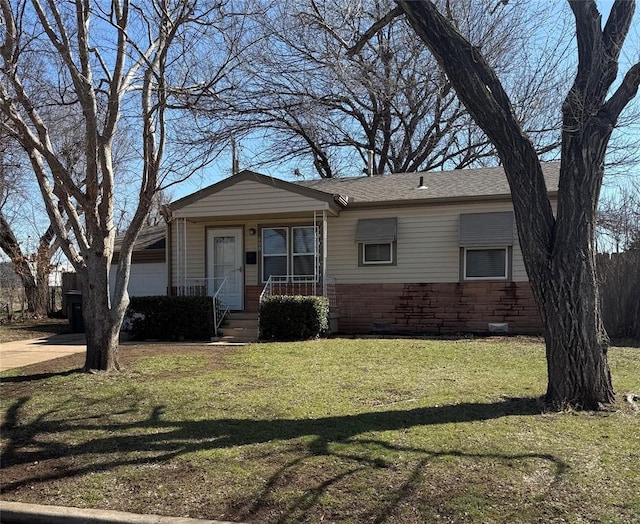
174,180,328,217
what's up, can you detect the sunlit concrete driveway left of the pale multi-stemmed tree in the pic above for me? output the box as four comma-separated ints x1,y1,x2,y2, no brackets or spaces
0,333,87,371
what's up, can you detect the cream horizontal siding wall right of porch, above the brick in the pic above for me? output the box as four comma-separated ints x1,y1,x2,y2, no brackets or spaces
327,202,527,284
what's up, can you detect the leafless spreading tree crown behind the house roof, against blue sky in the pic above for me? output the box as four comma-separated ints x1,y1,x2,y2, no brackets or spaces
214,0,569,178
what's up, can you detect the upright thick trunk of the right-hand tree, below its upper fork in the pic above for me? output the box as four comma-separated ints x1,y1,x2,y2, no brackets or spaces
534,114,615,409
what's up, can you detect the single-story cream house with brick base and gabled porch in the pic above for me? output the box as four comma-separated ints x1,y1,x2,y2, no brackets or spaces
167,163,559,333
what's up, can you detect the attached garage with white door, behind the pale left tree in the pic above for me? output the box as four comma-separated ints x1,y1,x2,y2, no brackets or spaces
109,223,167,297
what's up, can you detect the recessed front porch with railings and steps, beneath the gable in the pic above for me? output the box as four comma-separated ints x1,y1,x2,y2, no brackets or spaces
170,211,337,338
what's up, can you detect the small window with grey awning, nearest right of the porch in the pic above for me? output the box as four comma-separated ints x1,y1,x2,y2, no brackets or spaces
356,218,398,266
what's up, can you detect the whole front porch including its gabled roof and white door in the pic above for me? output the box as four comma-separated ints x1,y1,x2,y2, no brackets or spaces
167,171,346,340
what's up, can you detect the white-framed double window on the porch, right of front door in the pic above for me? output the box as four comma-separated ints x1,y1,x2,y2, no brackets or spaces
262,226,318,282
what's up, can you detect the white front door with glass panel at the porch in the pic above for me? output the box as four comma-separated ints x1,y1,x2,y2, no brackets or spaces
207,228,244,311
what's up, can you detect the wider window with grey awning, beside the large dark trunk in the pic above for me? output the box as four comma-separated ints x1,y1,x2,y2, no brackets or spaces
459,211,516,280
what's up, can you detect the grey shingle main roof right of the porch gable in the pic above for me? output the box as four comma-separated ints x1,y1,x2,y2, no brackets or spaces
294,162,560,206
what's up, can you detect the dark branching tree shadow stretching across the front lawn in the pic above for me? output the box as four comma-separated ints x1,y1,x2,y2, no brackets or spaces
0,397,566,522
